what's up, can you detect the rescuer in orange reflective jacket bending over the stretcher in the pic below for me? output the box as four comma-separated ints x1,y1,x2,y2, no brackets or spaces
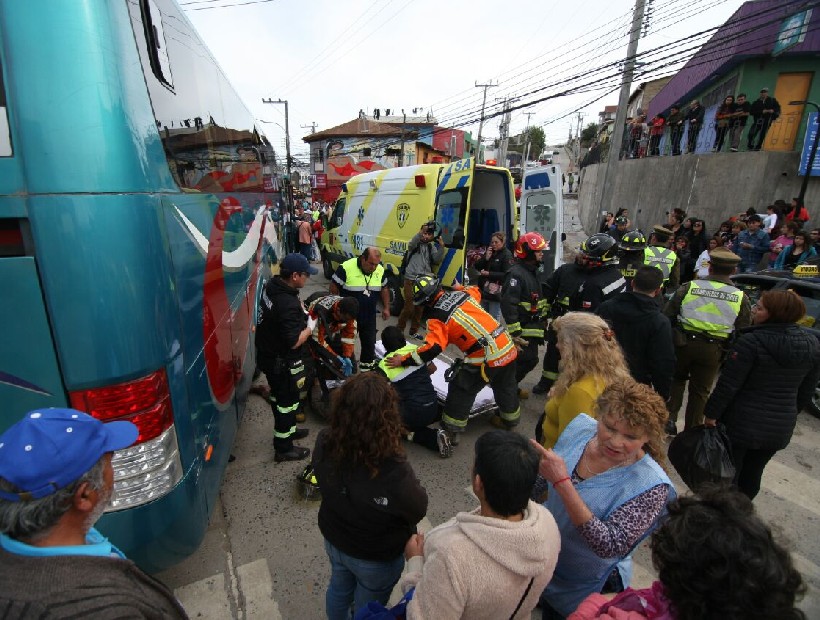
387,274,521,446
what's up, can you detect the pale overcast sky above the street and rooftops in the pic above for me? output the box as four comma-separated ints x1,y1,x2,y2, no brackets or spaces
184,0,743,158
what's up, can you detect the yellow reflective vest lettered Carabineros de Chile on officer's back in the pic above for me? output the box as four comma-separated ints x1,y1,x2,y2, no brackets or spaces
678,280,743,339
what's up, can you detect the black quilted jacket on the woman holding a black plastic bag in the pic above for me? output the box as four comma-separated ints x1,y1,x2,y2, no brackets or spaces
704,323,820,450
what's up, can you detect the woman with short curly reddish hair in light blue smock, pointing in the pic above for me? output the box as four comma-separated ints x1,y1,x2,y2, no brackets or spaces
532,380,676,620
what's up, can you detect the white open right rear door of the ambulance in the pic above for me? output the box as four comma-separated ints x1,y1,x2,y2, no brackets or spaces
518,164,567,277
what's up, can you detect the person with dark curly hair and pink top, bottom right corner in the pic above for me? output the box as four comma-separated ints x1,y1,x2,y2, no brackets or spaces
569,487,806,620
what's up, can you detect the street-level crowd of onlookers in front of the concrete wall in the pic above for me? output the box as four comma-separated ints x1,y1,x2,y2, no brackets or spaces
600,198,820,283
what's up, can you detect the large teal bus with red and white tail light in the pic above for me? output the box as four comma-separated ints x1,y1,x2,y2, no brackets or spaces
0,0,279,571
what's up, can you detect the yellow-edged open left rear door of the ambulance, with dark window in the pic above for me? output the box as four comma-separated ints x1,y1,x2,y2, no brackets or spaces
435,157,475,286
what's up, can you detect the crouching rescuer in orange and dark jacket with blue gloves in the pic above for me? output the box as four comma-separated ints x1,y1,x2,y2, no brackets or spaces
305,291,359,377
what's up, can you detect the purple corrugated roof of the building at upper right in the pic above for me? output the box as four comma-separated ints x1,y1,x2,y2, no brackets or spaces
649,0,820,116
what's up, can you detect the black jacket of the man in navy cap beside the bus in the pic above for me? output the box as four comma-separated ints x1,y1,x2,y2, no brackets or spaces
256,276,307,370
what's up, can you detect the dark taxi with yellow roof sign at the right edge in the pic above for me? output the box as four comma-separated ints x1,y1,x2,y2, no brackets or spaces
732,264,820,418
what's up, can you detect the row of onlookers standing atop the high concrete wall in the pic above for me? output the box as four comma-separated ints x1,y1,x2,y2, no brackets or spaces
621,88,780,159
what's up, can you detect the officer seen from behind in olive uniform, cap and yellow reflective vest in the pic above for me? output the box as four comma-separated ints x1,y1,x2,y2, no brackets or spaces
663,248,752,435
